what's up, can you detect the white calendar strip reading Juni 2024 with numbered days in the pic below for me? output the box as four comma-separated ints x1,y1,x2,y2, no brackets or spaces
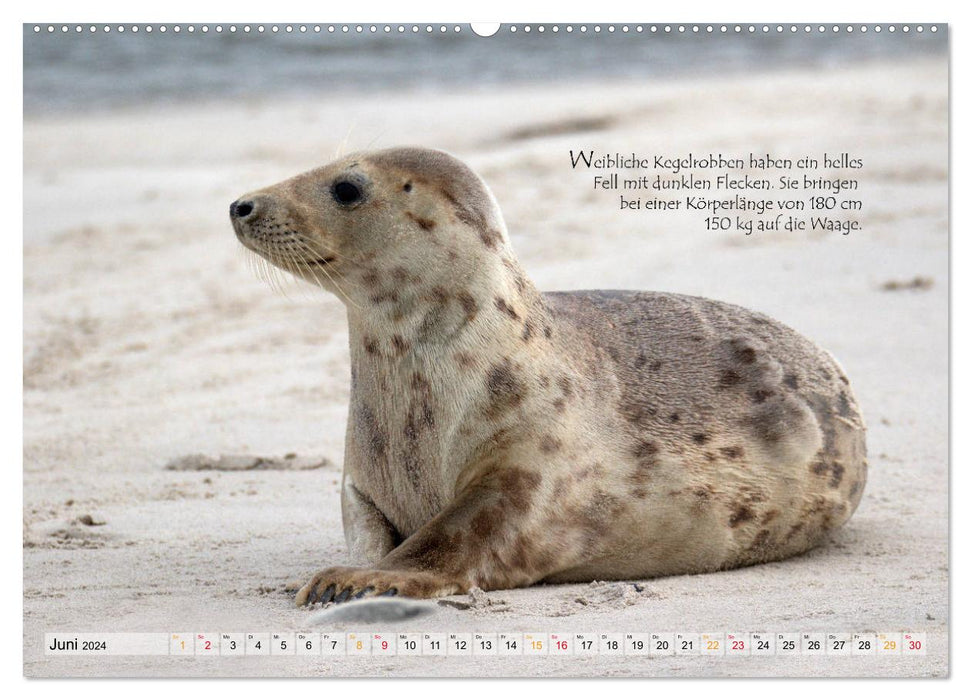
44,632,927,657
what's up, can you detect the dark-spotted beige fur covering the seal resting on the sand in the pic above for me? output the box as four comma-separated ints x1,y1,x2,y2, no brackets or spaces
234,148,866,603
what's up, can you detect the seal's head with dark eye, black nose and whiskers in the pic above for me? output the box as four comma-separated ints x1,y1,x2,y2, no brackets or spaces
229,148,508,304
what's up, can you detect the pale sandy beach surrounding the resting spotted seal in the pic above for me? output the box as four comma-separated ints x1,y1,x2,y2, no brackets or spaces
23,56,949,677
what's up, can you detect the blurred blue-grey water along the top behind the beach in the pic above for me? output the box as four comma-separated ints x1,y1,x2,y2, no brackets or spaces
23,25,947,115
